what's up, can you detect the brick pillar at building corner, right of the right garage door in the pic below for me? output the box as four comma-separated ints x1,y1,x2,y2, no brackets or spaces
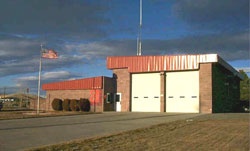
199,63,212,113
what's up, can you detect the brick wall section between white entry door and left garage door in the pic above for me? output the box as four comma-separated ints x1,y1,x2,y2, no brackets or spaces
113,68,131,112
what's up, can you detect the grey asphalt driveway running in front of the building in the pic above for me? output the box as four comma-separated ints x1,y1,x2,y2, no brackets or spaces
0,112,201,151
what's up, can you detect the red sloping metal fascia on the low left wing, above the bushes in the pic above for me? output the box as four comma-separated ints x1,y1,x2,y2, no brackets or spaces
42,77,103,90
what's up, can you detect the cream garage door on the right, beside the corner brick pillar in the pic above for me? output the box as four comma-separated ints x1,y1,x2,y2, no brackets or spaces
166,71,199,113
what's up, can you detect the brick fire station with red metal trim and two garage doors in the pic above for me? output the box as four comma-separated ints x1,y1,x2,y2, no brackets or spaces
43,54,242,113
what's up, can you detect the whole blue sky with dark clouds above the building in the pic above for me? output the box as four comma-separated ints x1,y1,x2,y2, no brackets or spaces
0,0,250,94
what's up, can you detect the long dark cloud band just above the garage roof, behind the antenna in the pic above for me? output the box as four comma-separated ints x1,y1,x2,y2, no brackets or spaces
60,32,249,61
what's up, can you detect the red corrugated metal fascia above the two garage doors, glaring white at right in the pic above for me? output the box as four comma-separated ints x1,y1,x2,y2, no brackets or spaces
107,54,218,72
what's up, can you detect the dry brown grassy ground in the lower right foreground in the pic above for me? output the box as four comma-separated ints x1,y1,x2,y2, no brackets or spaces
28,113,250,151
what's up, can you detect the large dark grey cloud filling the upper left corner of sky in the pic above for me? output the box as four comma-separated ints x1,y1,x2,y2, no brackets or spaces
0,0,109,39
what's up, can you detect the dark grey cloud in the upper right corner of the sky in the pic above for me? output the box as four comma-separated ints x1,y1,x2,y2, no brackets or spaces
173,0,249,32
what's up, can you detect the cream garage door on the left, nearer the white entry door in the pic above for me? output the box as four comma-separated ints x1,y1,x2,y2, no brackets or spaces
132,73,160,112
